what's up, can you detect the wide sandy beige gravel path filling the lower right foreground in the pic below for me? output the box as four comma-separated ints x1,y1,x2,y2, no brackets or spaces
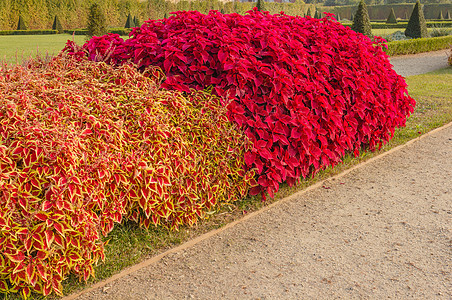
65,55,452,299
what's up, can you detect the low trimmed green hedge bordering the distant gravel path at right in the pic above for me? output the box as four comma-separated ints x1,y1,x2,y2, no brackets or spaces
385,35,452,56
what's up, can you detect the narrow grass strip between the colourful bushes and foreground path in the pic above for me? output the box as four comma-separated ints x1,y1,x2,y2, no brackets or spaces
47,67,452,295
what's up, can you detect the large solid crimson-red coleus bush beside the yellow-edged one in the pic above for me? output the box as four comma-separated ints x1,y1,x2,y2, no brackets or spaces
74,11,415,199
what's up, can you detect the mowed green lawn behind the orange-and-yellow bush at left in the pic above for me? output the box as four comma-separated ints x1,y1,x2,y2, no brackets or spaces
0,34,86,64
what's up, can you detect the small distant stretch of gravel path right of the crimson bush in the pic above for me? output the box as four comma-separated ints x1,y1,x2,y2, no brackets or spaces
390,50,450,77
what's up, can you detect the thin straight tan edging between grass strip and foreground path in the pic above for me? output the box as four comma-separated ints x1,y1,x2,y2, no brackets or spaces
61,122,452,300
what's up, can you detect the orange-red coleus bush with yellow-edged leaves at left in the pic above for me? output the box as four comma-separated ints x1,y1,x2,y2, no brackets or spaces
0,56,254,295
